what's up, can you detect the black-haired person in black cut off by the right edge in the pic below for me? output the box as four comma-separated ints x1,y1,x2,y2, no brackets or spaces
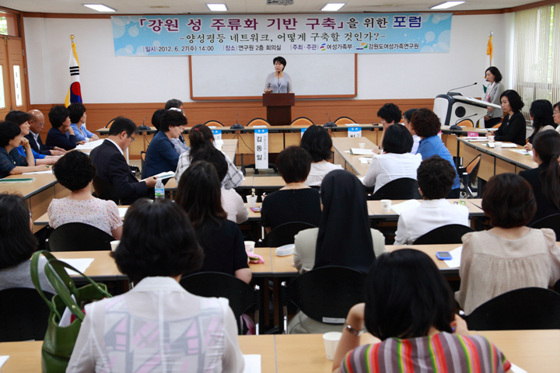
533,130,560,209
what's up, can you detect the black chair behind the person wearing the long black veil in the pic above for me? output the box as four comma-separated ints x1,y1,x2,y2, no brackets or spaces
280,266,366,333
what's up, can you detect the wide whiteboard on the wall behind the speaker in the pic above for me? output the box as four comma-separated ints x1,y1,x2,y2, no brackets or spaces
190,54,357,99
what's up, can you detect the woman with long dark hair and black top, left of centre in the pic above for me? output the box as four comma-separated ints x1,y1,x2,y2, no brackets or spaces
175,161,252,283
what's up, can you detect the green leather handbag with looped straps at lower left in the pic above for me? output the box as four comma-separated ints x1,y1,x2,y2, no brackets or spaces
31,250,111,373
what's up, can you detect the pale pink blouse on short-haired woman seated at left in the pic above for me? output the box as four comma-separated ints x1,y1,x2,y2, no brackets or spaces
47,198,122,235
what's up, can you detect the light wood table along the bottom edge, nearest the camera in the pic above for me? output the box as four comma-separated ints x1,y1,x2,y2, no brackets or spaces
0,328,560,373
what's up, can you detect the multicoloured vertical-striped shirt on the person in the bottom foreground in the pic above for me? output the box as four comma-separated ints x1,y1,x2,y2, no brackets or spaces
341,332,511,373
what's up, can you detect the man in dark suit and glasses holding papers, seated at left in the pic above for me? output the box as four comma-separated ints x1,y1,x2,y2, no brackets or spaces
90,117,156,205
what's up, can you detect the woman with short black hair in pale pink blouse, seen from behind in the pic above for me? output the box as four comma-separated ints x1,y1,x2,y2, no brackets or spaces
48,151,122,240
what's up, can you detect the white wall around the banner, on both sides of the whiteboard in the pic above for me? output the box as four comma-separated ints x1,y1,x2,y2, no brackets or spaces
24,14,511,105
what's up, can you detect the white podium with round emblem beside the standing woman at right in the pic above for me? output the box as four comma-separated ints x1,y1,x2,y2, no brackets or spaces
434,92,501,127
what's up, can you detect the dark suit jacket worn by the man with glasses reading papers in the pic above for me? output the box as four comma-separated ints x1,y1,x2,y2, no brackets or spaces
90,140,148,205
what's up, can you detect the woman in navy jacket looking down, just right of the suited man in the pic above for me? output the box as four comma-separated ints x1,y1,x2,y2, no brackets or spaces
142,110,187,178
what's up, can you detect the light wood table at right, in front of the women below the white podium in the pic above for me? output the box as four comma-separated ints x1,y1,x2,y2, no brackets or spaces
457,137,538,181
